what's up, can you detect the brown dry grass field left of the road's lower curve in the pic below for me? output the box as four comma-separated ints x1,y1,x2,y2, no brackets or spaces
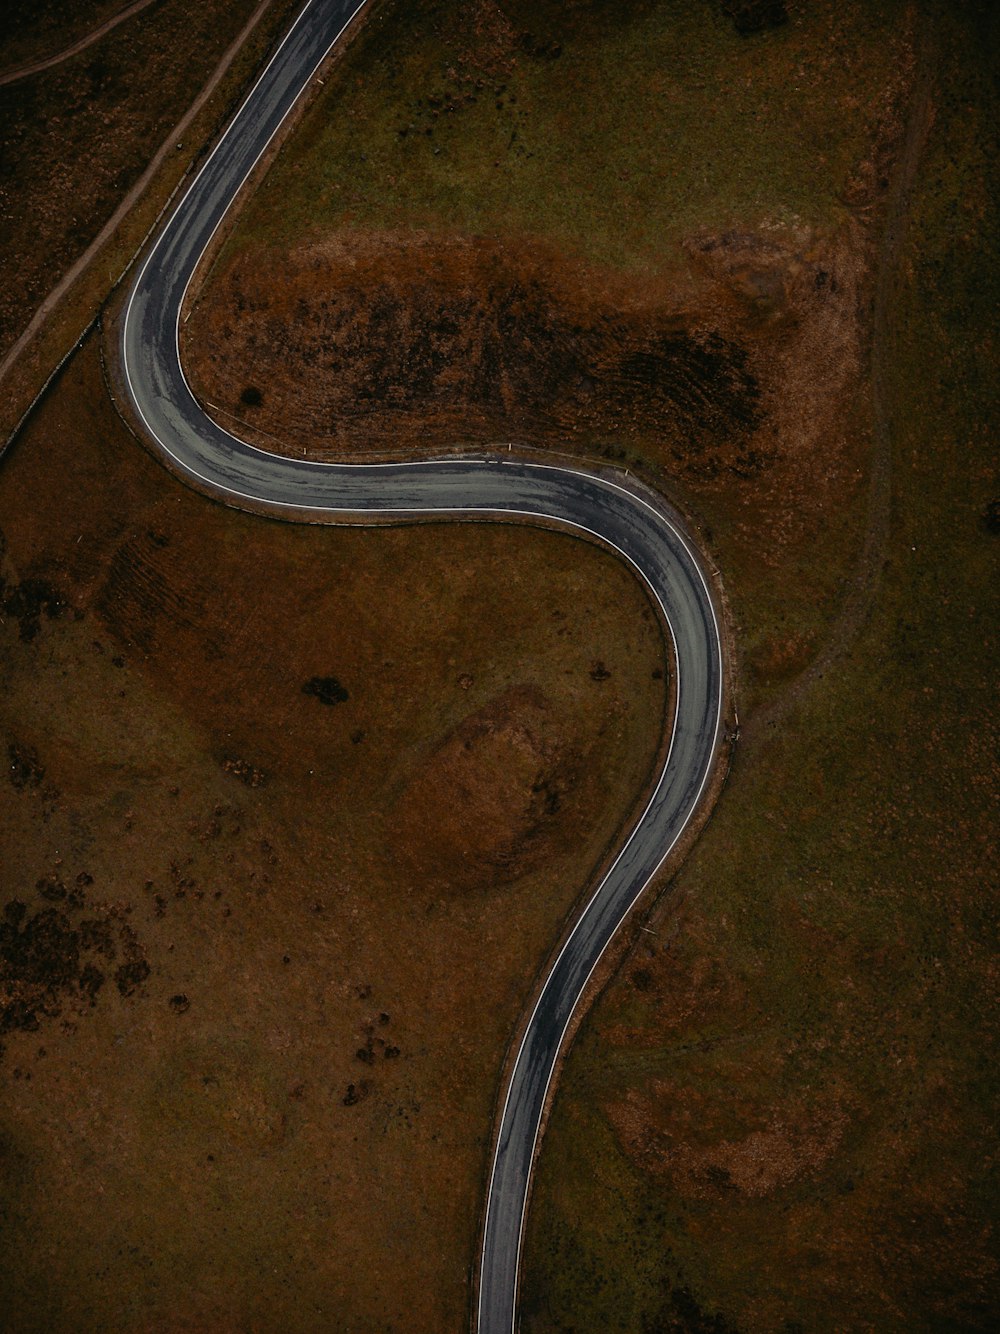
0,338,665,1331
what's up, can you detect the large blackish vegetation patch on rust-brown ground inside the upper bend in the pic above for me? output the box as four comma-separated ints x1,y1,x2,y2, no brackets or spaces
195,239,768,475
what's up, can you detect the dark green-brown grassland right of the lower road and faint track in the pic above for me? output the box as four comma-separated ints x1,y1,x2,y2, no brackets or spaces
524,9,997,1334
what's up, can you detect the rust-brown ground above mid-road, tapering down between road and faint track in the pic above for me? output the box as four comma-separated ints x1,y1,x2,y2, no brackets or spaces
184,216,871,714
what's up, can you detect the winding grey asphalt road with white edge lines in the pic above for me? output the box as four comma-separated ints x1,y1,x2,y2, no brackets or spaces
120,0,724,1334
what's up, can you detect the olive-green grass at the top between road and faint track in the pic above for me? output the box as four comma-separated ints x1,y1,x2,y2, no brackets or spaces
225,0,904,271
